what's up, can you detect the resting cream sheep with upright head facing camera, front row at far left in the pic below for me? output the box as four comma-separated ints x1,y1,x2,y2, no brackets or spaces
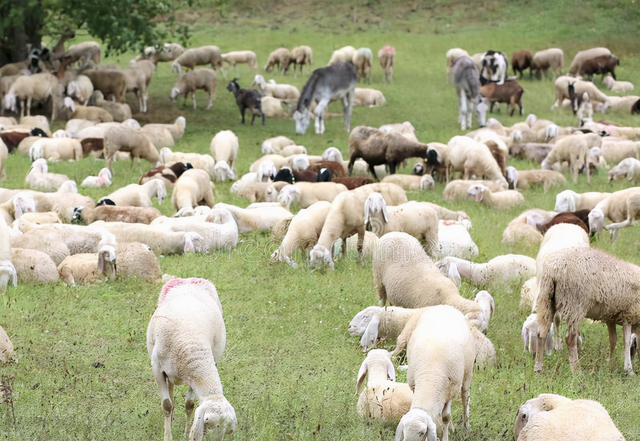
58,245,116,285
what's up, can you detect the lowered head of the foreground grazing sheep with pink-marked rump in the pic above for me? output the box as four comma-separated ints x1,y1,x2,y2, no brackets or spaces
189,397,238,441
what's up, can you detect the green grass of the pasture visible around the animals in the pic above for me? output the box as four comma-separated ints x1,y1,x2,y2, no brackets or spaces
0,0,640,441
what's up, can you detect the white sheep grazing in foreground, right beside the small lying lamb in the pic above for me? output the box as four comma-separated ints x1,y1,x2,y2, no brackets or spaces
394,305,475,441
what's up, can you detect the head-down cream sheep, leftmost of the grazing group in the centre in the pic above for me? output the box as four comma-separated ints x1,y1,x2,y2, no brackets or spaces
271,201,331,269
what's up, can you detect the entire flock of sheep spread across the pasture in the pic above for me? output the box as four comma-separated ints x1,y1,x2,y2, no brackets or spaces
0,31,640,441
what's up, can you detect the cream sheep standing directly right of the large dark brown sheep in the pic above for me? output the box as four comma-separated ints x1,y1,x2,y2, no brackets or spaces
445,136,508,182
